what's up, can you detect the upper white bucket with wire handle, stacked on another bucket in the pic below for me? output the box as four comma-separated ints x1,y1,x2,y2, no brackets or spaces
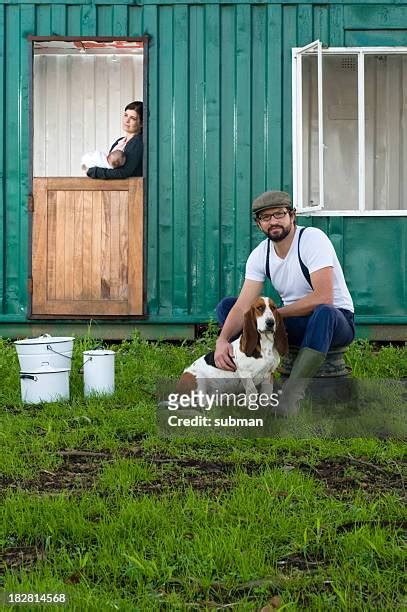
14,334,74,372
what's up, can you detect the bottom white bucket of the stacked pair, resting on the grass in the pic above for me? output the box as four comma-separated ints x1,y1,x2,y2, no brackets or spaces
20,367,69,404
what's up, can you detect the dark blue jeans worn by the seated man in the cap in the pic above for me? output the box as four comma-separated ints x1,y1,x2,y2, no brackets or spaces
216,297,355,354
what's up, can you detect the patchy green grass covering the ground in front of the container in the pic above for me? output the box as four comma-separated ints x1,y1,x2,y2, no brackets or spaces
0,331,407,611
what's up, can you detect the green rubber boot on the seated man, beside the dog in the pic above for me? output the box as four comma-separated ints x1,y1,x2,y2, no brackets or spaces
275,348,326,416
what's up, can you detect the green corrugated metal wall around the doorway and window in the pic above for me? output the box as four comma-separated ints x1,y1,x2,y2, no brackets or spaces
0,0,407,334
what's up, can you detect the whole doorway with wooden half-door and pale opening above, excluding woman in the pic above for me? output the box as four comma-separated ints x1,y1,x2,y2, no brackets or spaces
31,37,147,318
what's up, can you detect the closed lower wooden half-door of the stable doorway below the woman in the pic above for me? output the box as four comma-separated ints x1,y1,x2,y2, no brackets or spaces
32,178,143,318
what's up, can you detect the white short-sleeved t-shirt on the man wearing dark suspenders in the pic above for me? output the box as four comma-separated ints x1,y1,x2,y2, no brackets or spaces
246,226,354,312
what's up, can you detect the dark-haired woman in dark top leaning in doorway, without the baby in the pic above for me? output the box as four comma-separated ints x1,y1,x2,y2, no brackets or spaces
87,102,143,179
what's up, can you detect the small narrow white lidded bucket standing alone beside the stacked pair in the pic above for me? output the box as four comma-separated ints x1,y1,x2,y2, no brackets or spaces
83,349,115,397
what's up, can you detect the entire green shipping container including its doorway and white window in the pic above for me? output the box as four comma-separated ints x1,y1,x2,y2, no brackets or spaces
0,0,407,340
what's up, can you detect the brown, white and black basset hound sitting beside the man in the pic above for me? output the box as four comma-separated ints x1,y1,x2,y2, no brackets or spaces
177,297,288,396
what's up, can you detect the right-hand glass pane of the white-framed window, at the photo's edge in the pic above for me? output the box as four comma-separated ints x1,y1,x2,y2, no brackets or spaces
365,55,407,210
